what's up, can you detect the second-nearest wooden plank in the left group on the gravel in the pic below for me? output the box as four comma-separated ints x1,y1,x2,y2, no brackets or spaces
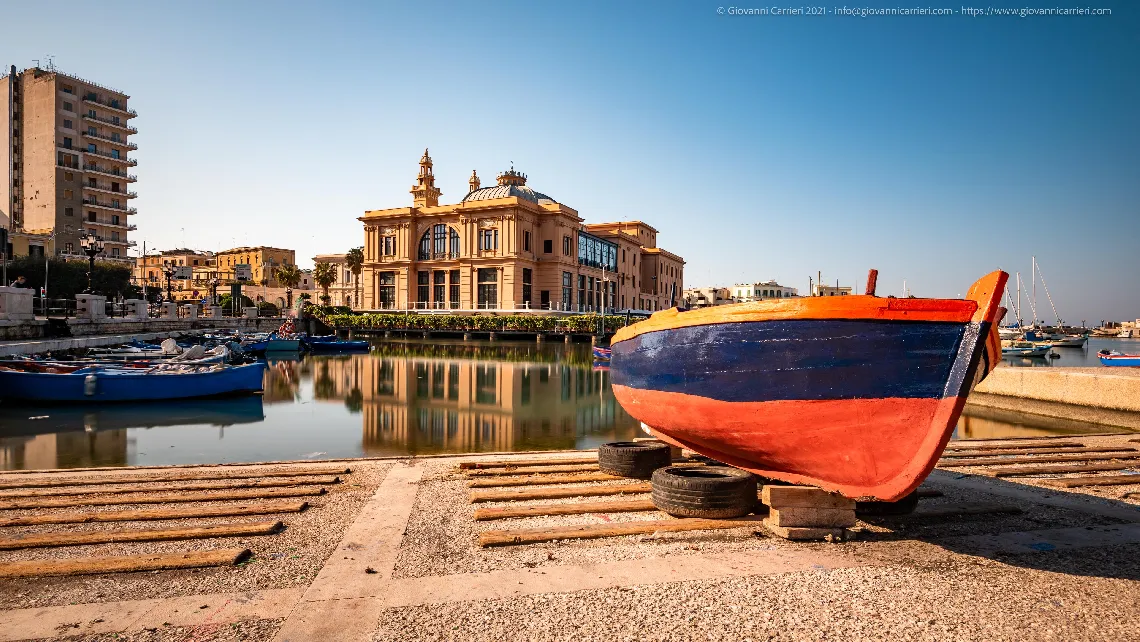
0,521,285,551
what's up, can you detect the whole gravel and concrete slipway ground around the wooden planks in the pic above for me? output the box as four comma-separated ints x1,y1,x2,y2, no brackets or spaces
0,436,1140,642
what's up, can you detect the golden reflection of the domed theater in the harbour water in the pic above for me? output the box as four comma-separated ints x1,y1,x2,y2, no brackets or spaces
282,343,637,455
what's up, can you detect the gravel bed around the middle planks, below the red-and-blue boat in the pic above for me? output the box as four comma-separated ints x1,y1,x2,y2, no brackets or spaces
394,462,1121,578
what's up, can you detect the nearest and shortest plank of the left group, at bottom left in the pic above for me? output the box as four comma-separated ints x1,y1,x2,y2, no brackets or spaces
0,548,250,578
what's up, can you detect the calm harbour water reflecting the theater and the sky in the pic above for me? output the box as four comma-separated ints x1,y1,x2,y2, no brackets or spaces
0,340,1140,470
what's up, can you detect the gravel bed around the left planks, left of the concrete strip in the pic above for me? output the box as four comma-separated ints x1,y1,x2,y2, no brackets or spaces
0,462,391,609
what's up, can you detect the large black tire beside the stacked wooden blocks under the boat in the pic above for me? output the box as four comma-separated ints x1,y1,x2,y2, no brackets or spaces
652,466,757,519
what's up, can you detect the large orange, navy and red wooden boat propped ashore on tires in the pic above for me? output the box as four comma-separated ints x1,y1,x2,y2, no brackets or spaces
610,270,1008,501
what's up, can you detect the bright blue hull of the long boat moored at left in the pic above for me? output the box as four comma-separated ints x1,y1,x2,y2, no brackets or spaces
0,364,266,403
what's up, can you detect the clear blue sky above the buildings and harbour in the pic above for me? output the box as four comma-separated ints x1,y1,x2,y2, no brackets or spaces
0,0,1140,323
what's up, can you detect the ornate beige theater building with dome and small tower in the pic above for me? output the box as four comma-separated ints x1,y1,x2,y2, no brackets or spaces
360,149,685,311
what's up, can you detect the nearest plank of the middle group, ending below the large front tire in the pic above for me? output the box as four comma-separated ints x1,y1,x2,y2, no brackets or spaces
479,515,763,547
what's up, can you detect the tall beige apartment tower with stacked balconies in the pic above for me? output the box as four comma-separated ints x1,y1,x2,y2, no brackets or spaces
0,66,138,262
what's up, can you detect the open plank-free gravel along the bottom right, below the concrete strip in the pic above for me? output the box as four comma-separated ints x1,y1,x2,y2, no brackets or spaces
375,545,1140,642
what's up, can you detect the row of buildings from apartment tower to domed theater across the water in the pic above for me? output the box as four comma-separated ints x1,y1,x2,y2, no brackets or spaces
0,65,685,311
